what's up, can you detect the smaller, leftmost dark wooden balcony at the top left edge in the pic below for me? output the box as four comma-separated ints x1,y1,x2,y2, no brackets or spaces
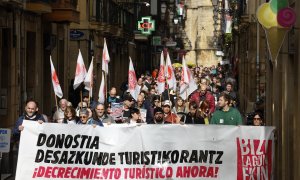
24,0,51,14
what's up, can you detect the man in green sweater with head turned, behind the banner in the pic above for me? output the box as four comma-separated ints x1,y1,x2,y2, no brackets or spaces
211,93,243,125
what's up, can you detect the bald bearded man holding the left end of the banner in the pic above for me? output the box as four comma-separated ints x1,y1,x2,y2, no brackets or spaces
13,100,45,141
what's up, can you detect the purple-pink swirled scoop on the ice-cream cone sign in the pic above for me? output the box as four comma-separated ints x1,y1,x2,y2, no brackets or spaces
277,7,296,28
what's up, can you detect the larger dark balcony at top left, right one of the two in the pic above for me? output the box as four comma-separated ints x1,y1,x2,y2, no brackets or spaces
43,0,79,23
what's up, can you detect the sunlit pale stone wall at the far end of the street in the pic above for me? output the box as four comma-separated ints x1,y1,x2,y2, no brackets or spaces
185,0,221,66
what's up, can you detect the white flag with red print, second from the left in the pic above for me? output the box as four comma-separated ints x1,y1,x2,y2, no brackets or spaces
73,49,86,89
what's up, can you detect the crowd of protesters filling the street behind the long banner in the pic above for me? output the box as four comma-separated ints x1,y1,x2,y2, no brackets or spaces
13,65,263,141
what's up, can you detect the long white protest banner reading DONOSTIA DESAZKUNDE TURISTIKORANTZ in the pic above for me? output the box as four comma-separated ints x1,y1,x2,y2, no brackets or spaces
16,121,274,180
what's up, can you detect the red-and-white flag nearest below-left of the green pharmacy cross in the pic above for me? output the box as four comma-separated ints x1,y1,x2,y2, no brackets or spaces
128,57,140,101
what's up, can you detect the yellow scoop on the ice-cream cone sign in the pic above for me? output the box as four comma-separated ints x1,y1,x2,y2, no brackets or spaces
256,3,278,29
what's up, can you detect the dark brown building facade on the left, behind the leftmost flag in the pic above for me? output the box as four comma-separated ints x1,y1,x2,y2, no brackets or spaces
0,0,79,127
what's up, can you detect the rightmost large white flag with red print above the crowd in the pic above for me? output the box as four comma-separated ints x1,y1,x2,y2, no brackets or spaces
179,57,198,100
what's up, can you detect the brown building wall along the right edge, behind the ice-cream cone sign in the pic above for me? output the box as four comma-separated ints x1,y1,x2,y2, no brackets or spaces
236,0,300,180
